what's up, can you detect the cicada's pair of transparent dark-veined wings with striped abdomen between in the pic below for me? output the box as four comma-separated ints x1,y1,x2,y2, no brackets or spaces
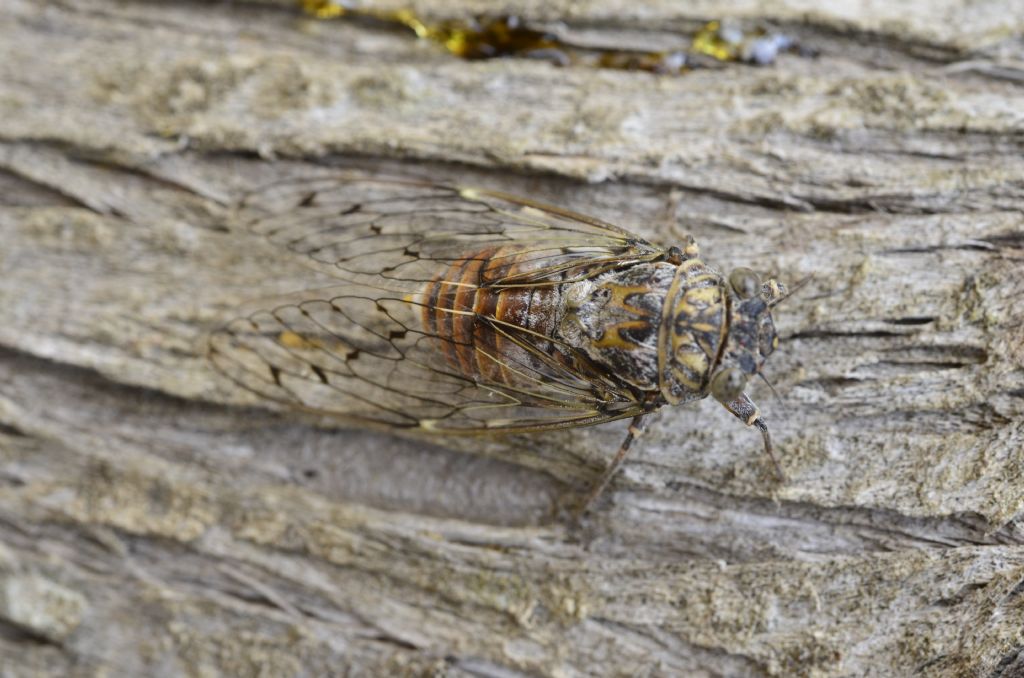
210,177,662,432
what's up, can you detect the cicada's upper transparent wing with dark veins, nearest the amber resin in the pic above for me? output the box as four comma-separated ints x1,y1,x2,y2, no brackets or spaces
235,176,663,291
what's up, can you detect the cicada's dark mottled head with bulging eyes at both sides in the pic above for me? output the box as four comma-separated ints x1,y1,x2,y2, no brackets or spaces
711,268,785,405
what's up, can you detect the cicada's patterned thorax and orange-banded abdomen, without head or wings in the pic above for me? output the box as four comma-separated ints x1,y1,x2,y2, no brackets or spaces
423,248,727,404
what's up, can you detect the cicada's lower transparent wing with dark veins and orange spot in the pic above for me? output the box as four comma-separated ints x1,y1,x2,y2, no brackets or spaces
210,289,635,432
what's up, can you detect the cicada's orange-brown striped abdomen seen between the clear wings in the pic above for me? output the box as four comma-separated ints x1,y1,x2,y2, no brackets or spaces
423,248,560,384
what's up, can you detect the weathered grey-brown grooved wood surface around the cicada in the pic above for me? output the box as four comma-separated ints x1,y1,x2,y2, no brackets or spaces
0,0,1024,676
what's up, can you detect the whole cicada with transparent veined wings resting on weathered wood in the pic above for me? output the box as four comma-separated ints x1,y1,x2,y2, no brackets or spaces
210,174,784,507
